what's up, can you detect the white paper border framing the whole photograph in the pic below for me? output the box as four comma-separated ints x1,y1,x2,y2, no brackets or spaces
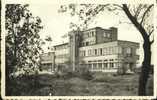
1,0,157,100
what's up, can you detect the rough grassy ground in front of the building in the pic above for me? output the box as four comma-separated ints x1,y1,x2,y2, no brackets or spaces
7,73,153,96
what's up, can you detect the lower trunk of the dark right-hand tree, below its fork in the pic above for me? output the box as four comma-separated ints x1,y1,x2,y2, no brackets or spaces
138,41,151,96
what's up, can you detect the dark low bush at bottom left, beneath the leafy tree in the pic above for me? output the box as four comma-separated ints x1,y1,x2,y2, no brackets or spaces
6,74,43,96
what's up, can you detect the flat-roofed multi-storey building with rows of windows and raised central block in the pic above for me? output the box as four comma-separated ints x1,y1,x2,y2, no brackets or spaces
39,27,139,72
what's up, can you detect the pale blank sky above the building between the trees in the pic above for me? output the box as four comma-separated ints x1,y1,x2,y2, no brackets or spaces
29,4,143,63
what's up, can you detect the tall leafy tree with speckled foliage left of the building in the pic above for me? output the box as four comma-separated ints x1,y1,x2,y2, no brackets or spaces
5,4,42,95
